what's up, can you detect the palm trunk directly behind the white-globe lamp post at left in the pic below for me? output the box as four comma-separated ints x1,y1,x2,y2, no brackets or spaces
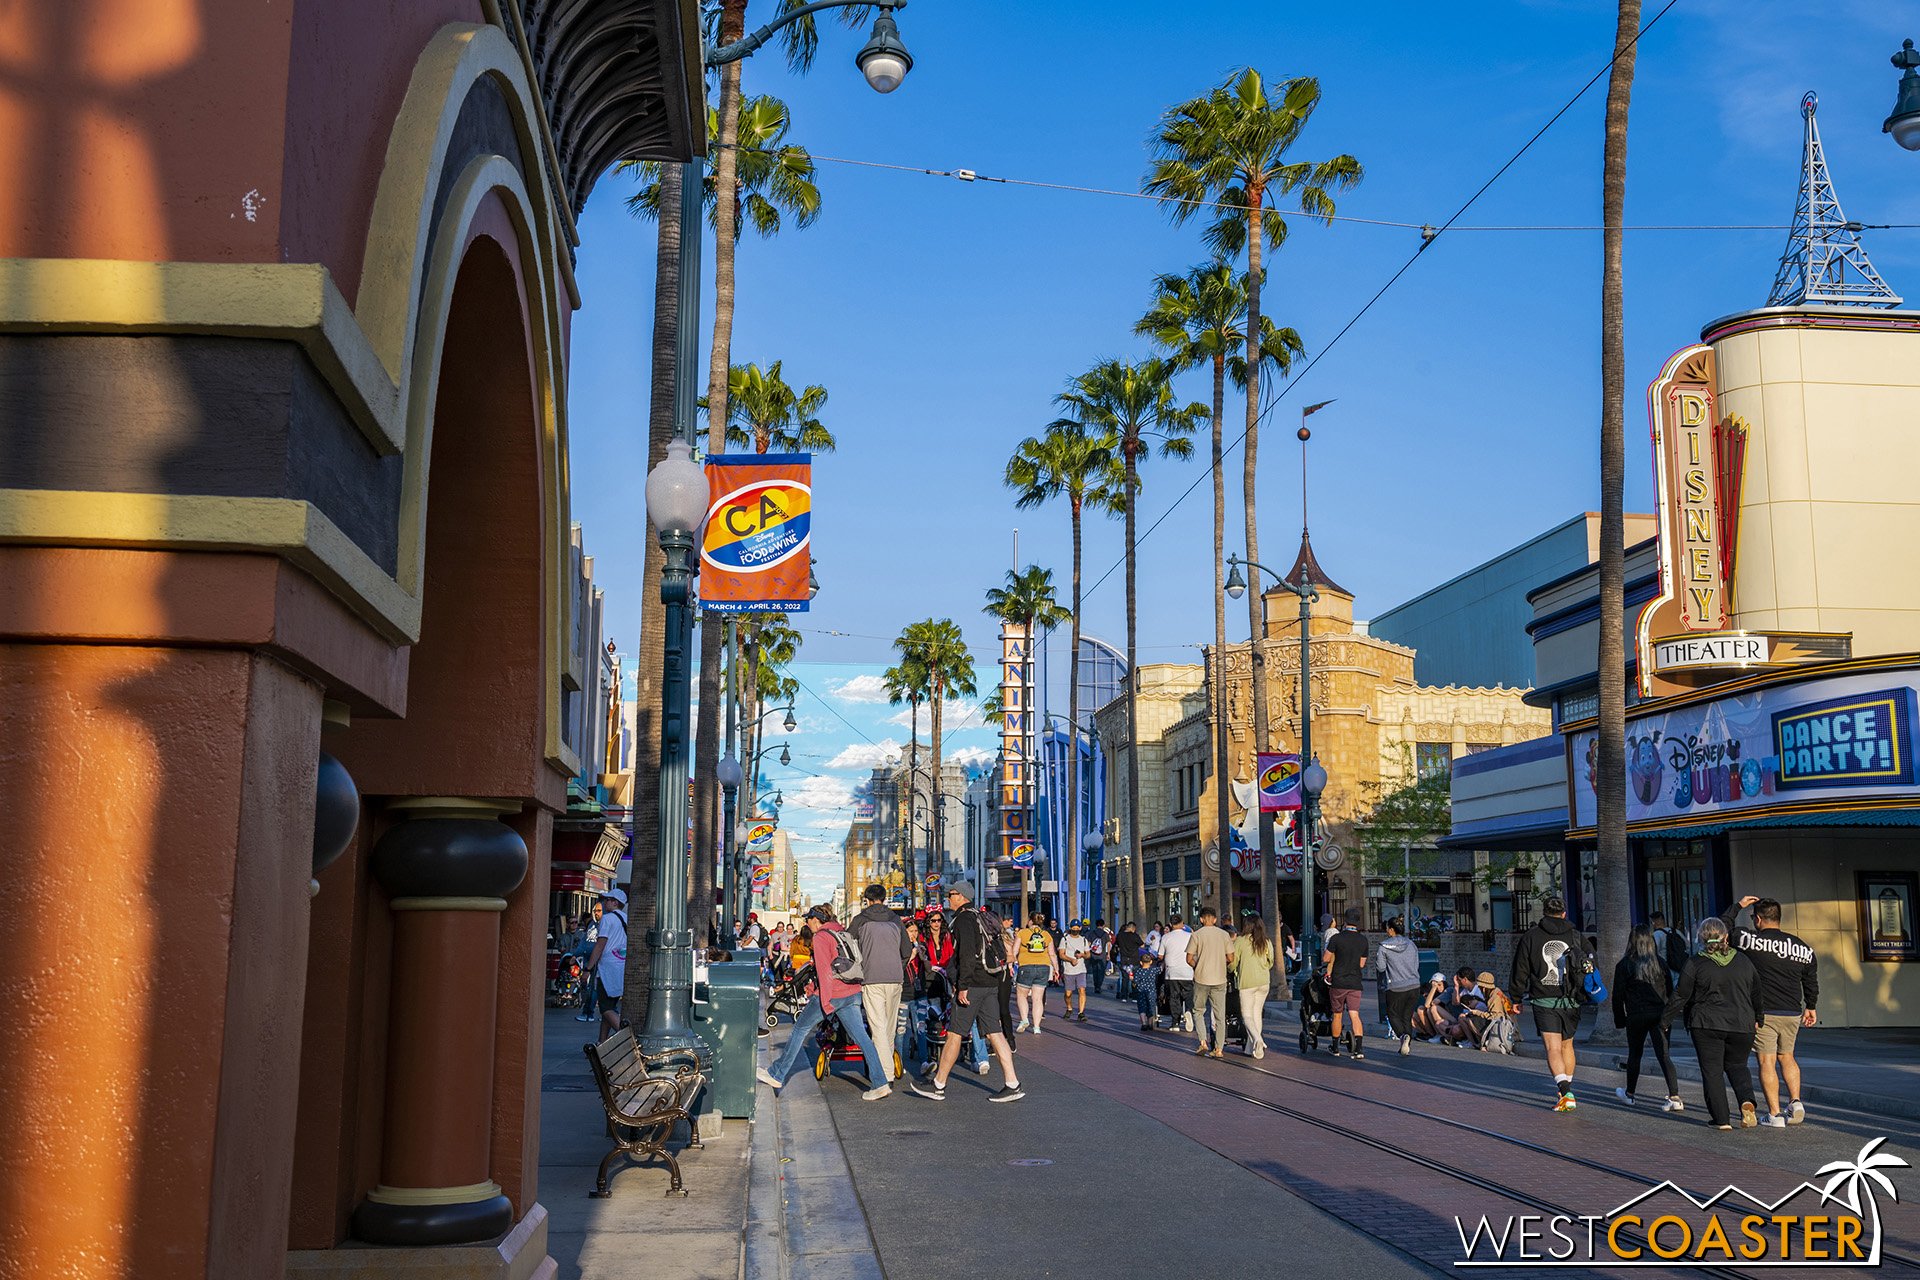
620,165,684,1027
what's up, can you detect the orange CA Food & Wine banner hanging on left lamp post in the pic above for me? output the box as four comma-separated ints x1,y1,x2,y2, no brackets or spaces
701,453,814,614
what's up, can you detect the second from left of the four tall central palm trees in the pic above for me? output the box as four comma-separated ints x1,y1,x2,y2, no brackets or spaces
1054,357,1206,932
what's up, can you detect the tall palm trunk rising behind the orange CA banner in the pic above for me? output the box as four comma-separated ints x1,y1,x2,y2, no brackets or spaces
687,0,747,946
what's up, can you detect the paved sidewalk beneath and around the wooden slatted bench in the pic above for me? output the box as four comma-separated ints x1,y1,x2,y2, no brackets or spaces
540,1009,755,1280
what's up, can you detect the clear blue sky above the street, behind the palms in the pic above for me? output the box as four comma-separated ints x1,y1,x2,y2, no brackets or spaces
568,0,1920,898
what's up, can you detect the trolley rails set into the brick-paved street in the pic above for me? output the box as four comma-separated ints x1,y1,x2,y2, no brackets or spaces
1048,1029,1920,1280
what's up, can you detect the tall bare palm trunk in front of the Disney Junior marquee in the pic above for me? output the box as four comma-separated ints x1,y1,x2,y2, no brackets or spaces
1594,0,1640,1036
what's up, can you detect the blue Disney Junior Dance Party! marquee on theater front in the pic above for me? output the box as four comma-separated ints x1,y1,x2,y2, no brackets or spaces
1569,668,1920,827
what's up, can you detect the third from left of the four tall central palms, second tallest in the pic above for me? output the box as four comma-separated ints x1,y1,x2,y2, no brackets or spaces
1133,257,1302,936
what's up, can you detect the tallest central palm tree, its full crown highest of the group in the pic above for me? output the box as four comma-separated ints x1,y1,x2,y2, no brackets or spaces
1144,67,1361,951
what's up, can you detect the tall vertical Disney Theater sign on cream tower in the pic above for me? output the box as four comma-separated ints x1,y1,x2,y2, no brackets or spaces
1636,344,1851,697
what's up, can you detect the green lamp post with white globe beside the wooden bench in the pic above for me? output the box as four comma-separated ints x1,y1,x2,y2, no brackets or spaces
641,439,707,1054
